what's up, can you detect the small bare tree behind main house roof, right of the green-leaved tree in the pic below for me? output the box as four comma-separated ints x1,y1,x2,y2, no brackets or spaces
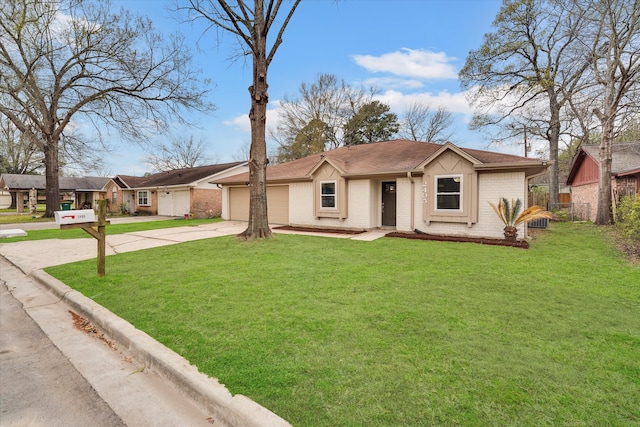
399,102,453,144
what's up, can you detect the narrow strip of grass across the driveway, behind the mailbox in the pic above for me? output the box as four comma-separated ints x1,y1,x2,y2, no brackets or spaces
0,218,222,243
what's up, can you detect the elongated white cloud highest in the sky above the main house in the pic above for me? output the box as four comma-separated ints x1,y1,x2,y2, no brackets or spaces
353,48,458,79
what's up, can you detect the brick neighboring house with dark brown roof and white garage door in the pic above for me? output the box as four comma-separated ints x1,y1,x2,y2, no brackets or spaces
104,161,249,218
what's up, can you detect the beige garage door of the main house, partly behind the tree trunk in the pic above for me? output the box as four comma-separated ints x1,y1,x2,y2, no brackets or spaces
229,185,289,224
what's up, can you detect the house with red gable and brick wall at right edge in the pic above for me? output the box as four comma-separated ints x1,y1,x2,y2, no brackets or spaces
567,142,640,221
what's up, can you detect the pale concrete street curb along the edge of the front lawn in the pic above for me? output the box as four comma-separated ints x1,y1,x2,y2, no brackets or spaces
30,270,291,427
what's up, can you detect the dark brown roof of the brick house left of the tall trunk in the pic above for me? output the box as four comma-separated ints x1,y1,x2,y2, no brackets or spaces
114,161,247,188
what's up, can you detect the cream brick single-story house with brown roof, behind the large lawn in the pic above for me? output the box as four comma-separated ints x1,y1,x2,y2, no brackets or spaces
214,140,547,238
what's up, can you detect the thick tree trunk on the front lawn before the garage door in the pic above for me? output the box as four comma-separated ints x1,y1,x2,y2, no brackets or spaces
239,2,271,240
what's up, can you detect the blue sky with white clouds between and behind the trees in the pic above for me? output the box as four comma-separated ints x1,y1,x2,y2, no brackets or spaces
105,0,510,175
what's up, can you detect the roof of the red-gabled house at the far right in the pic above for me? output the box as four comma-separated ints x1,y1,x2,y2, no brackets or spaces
567,142,640,185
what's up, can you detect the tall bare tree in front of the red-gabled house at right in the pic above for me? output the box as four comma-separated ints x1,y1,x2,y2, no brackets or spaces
586,0,640,225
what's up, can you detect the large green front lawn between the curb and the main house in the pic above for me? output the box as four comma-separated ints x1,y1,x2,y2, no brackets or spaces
47,224,640,426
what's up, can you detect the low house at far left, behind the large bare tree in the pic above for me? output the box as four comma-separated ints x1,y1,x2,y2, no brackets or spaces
0,173,109,212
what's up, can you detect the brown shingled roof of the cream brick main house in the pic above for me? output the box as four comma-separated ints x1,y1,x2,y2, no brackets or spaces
213,140,546,184
